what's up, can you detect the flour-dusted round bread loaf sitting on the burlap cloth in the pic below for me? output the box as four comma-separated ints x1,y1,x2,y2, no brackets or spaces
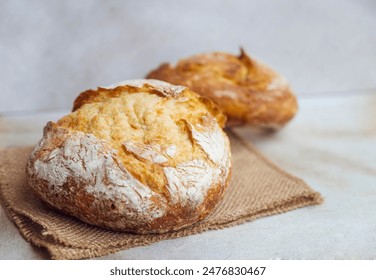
27,80,231,233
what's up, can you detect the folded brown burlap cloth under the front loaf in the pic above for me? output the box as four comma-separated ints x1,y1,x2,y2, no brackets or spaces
0,132,322,259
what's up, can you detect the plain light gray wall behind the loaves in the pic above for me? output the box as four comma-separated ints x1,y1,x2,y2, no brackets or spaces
0,0,376,114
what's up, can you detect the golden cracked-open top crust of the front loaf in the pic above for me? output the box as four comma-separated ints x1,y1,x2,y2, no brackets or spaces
57,80,225,194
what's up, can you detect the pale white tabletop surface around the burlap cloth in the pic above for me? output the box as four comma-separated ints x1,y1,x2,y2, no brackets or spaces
0,91,376,259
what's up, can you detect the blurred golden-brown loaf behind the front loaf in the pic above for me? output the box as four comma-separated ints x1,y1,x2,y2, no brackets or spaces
147,49,298,128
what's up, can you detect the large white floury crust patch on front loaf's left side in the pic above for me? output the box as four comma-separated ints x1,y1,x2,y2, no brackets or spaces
29,124,165,220
